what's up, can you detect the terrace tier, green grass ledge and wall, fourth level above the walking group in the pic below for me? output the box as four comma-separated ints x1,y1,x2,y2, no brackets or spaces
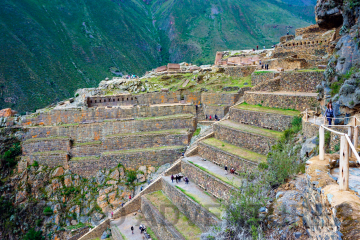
230,103,300,131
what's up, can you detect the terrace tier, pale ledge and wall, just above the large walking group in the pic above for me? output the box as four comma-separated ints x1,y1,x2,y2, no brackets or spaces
181,156,242,200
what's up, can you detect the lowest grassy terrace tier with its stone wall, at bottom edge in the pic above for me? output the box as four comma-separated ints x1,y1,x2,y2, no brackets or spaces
145,190,202,240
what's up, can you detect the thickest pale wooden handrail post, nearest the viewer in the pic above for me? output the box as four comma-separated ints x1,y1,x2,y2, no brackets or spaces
339,136,349,191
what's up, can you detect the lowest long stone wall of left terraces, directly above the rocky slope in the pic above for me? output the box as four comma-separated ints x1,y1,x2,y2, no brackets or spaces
69,147,184,177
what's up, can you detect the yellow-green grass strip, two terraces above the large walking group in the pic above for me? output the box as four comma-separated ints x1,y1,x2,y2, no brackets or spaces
203,138,266,163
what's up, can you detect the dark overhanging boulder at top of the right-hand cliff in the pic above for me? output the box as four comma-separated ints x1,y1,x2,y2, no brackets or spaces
315,0,343,29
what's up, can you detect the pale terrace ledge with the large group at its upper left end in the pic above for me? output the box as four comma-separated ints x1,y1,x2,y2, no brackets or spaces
163,176,222,218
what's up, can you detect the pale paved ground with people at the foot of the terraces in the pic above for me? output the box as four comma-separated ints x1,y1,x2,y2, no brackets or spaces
110,212,149,240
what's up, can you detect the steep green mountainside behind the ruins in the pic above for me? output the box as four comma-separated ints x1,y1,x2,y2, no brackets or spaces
0,0,316,113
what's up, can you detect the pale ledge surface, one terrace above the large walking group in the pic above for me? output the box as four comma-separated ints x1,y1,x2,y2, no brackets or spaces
183,156,242,187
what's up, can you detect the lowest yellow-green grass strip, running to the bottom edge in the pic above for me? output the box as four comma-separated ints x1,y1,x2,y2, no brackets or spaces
145,191,202,240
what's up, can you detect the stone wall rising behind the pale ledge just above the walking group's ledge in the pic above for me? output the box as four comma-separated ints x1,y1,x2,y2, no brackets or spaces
198,142,258,172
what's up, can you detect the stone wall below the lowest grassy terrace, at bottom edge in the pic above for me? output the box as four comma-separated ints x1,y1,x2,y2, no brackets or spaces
141,196,185,240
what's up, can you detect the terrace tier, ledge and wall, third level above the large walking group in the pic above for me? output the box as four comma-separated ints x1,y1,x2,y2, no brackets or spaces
213,120,282,155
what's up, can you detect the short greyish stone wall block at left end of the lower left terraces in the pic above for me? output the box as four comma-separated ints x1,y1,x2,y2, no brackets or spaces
21,137,70,155
